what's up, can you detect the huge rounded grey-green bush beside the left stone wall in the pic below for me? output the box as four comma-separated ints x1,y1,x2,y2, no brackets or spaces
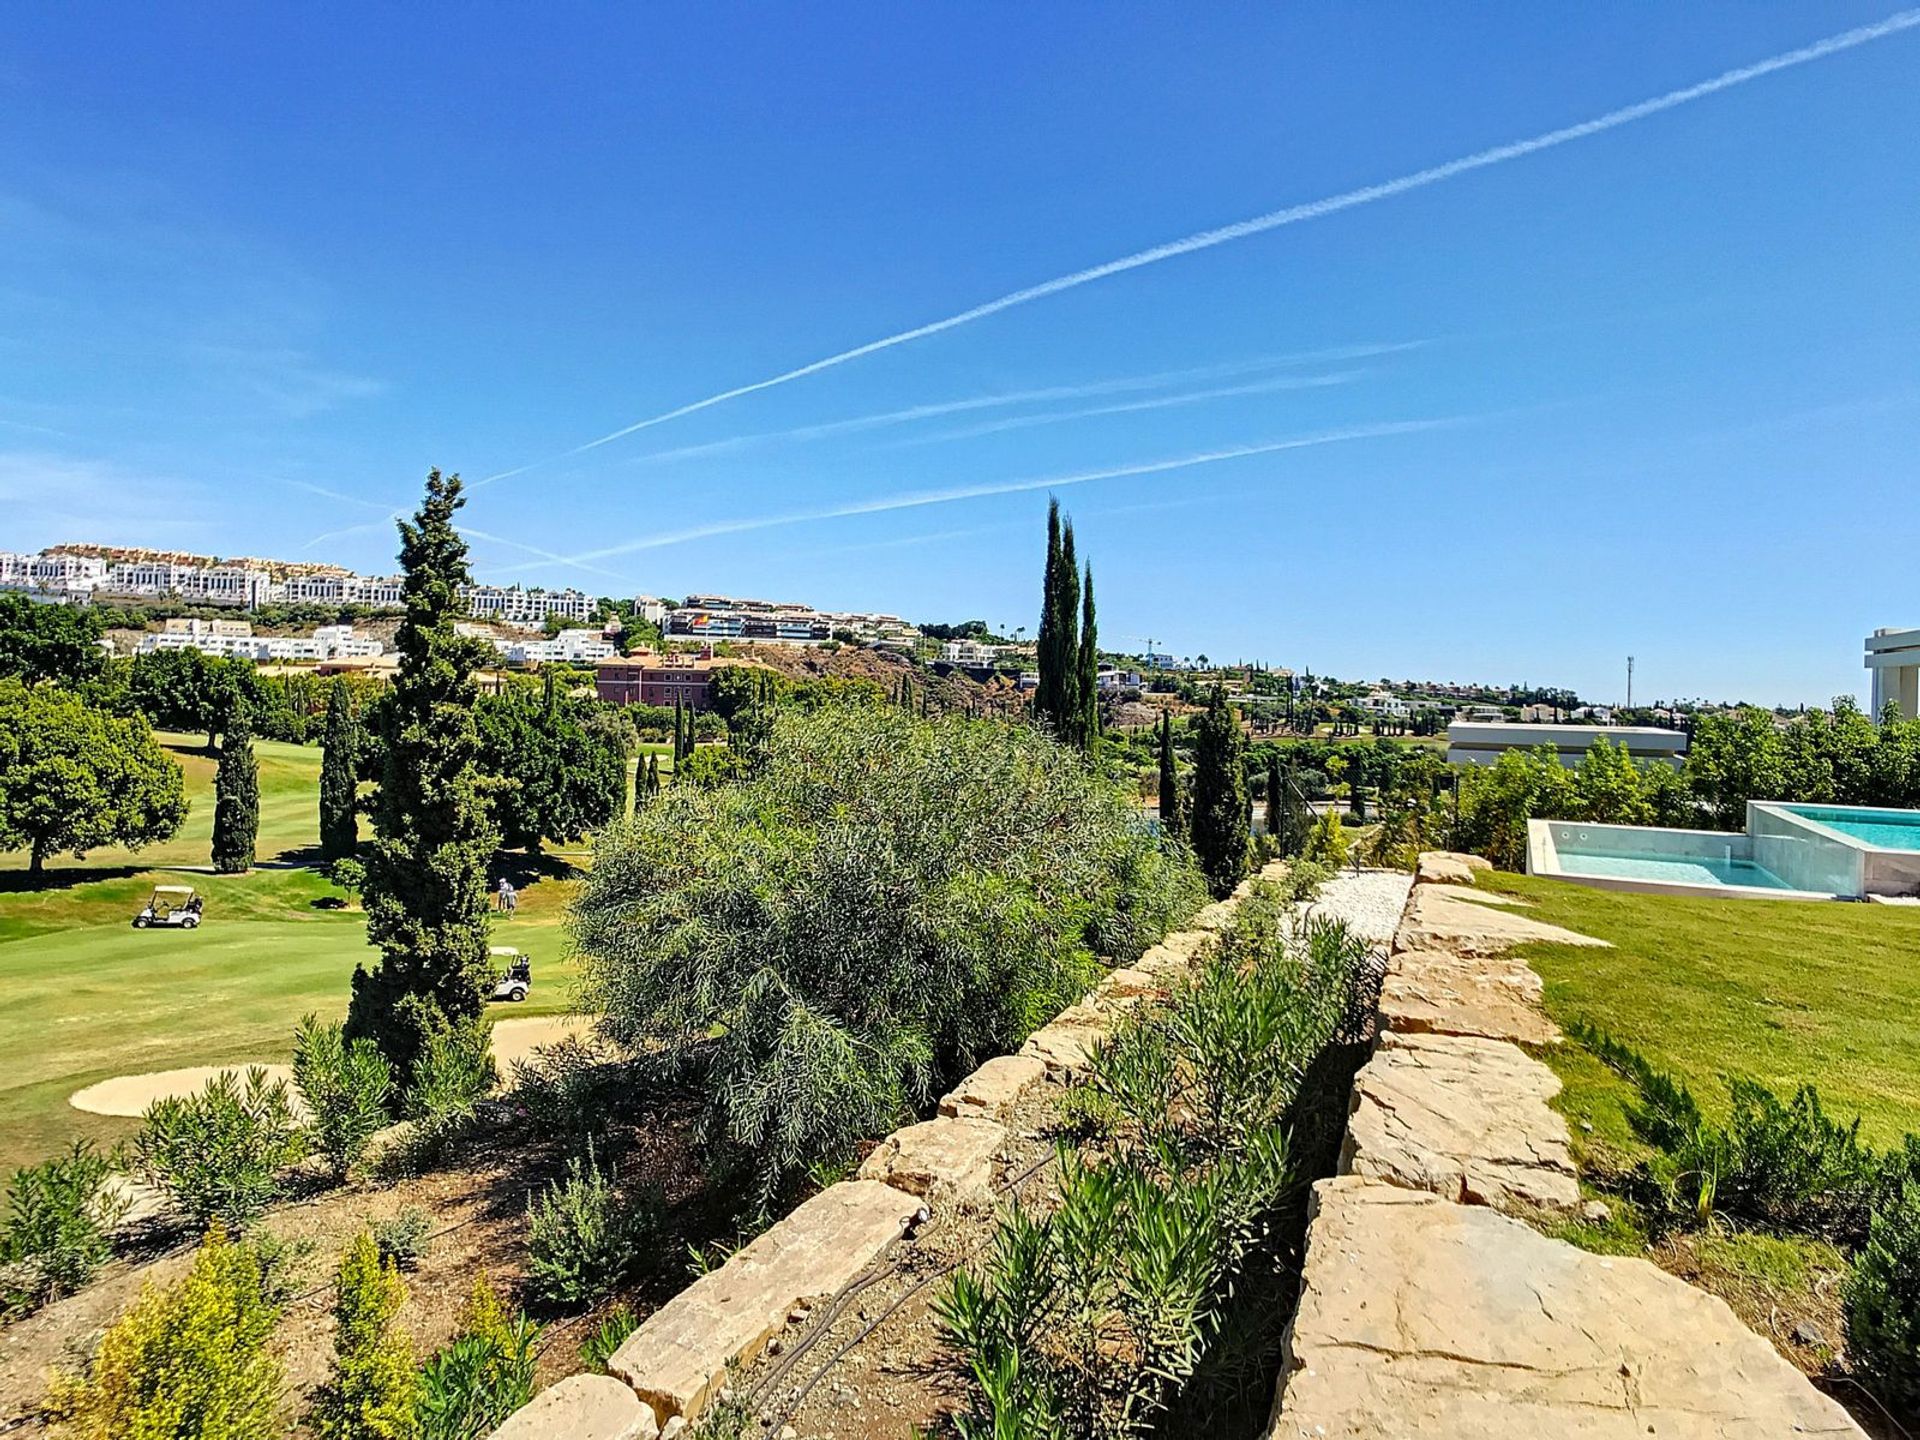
574,707,1200,1206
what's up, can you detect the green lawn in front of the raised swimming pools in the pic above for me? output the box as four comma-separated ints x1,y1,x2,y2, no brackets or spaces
1480,874,1920,1144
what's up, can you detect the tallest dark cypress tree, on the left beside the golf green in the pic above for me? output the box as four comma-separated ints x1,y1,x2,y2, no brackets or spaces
348,470,497,1081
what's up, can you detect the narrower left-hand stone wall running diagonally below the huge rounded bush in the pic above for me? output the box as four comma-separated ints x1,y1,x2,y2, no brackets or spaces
492,866,1281,1440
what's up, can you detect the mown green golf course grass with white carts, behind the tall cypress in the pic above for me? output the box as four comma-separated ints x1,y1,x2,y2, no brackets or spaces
0,733,582,1169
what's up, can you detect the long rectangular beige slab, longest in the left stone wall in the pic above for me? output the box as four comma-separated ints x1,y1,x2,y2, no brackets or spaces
607,1181,920,1423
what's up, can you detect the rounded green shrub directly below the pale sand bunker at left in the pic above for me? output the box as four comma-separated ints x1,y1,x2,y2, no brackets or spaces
132,1068,305,1229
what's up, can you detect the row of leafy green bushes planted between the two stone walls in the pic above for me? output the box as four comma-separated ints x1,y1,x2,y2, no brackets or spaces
939,898,1369,1440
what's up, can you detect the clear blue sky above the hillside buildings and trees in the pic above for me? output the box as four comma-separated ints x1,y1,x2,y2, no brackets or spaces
0,4,1920,703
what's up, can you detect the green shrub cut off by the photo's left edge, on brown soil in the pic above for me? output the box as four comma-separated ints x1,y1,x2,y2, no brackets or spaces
0,1140,127,1309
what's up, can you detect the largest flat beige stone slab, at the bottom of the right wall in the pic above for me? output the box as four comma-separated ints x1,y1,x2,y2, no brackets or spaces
1267,1177,1862,1440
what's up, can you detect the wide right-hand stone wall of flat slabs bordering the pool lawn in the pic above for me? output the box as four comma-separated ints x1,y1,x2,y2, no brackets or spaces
1267,854,1862,1440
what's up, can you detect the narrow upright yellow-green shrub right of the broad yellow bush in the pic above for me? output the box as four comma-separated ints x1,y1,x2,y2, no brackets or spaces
309,1231,420,1440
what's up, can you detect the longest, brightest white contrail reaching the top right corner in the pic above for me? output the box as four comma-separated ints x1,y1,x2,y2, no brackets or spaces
482,10,1920,484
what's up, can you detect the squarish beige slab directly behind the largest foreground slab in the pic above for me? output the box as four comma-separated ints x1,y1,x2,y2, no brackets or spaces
1340,1033,1580,1210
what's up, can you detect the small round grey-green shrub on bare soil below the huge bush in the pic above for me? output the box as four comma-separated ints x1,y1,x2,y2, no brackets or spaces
526,1148,660,1306
